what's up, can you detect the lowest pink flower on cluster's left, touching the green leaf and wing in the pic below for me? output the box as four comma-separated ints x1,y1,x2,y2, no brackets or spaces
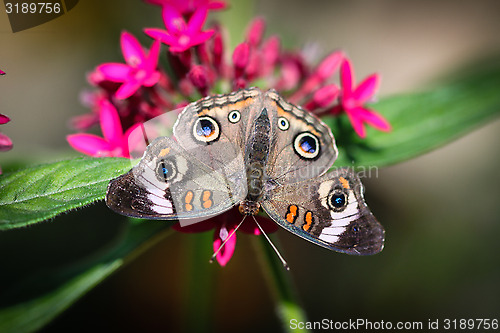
66,100,140,158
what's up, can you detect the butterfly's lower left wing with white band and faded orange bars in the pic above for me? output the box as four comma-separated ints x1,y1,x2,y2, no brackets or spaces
106,137,245,220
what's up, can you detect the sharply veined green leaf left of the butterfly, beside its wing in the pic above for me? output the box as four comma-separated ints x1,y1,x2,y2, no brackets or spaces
0,158,131,230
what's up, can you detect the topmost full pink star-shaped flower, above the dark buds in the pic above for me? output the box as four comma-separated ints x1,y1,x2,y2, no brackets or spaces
144,5,214,53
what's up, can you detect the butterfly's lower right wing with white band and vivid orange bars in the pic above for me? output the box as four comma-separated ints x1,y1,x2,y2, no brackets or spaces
263,169,384,255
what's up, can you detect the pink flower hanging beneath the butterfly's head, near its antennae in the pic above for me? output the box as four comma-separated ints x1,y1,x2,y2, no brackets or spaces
173,207,278,266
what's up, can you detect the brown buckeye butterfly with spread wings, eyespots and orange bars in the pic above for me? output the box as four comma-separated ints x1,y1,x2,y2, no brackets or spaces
106,88,385,255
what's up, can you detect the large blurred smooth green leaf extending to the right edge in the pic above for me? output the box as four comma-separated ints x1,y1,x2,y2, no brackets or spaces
325,57,500,166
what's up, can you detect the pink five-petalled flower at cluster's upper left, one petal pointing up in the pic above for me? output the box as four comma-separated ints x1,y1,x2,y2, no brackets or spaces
97,32,160,99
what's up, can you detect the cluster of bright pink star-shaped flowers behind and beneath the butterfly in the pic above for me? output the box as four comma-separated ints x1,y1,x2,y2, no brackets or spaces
67,0,390,265
